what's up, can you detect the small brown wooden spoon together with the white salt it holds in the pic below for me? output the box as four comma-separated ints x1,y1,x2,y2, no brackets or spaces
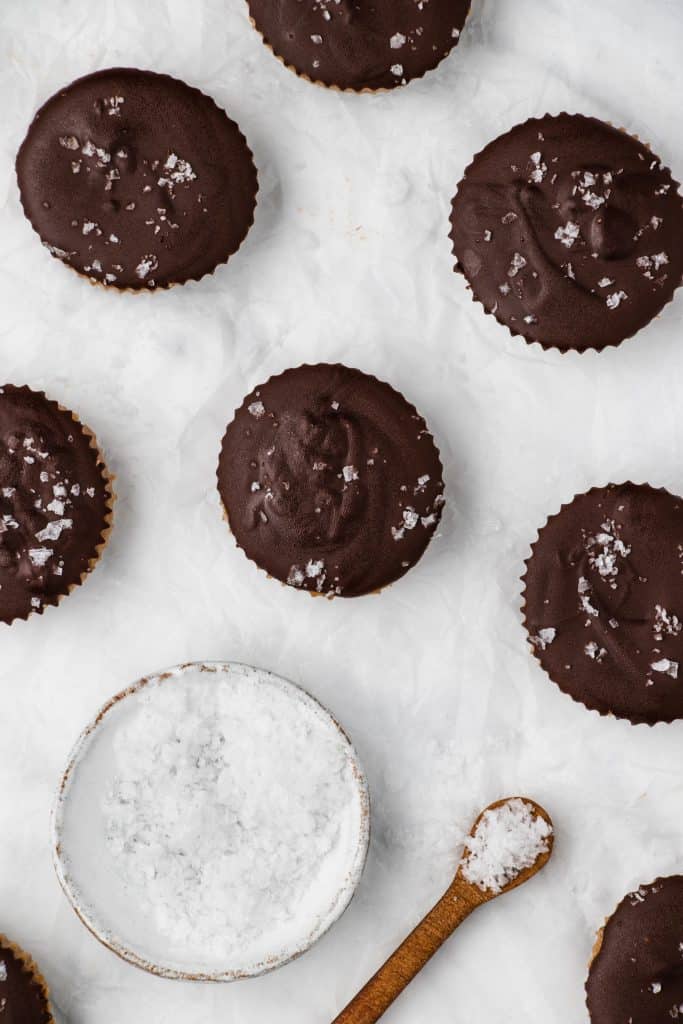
333,797,554,1024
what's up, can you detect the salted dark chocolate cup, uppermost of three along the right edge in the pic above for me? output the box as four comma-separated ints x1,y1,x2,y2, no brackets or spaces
451,114,683,351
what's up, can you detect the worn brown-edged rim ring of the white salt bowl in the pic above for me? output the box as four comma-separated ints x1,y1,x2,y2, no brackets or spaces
50,660,370,982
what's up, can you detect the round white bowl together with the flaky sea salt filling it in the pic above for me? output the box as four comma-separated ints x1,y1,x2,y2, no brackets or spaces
52,663,370,981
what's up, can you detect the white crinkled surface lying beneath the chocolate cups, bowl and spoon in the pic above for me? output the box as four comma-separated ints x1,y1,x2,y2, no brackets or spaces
0,0,683,1024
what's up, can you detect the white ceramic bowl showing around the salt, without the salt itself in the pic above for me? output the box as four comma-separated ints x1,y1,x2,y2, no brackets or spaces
52,662,370,981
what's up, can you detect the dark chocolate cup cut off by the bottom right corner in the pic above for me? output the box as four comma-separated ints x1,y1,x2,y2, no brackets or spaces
586,874,683,1024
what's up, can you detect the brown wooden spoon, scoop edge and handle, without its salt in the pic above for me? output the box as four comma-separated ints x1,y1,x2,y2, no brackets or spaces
333,797,553,1024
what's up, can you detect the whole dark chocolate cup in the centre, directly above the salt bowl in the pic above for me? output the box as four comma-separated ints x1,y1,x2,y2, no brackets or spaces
218,364,443,597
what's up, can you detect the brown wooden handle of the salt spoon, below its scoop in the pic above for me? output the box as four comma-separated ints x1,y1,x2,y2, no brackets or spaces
333,879,485,1024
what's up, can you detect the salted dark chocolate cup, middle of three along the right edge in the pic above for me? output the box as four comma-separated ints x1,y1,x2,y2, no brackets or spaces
525,483,683,729
